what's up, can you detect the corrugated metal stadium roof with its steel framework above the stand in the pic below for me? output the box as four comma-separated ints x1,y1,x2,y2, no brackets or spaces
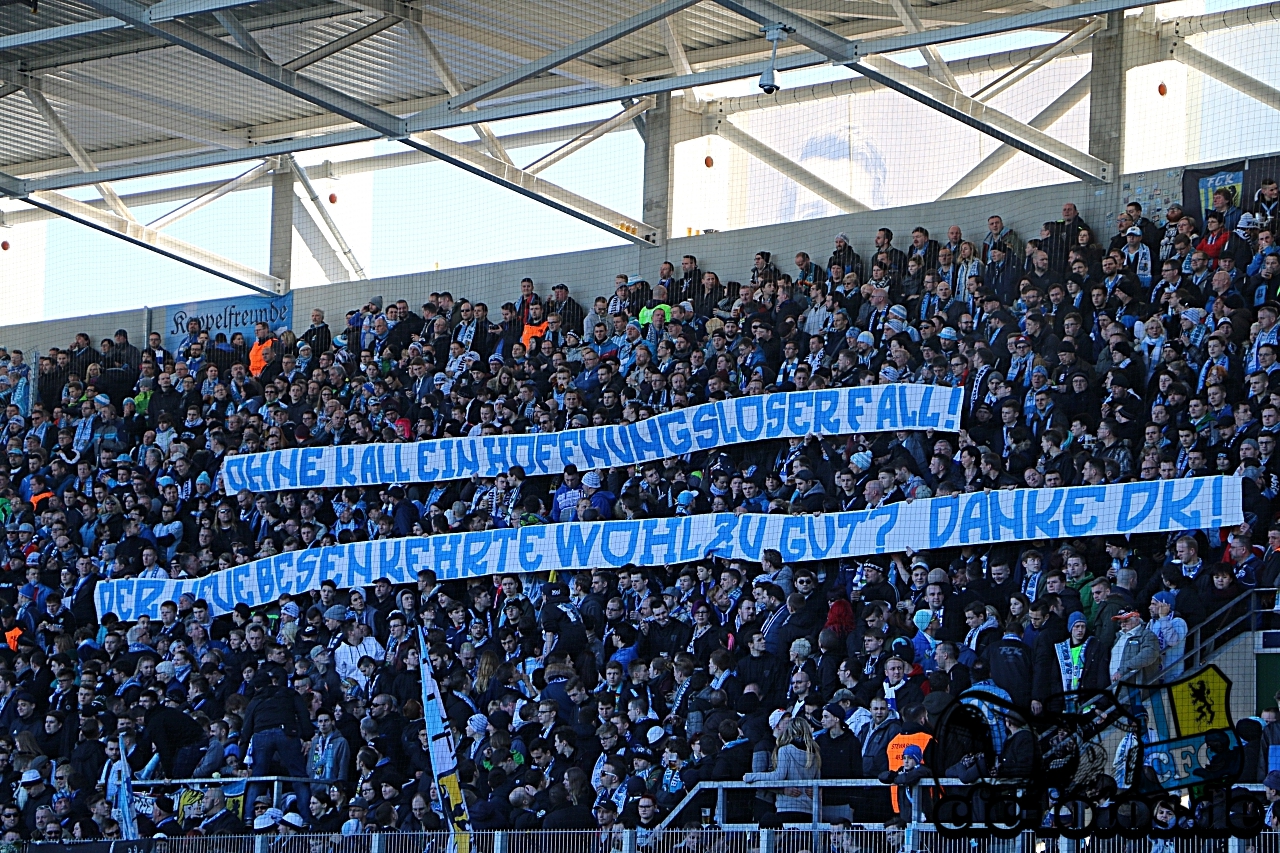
0,0,1274,284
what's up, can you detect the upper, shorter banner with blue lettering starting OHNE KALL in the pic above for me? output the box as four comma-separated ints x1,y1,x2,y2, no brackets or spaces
223,384,964,493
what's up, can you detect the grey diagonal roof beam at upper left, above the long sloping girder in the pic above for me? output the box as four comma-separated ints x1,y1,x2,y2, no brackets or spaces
80,0,407,138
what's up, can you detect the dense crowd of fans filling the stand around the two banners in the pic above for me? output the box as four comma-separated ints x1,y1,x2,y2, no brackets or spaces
0,181,1280,840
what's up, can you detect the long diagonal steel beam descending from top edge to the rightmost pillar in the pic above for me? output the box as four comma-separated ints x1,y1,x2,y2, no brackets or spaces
717,0,1112,181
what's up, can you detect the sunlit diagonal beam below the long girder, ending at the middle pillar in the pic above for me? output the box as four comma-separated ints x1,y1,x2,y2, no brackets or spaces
404,132,659,246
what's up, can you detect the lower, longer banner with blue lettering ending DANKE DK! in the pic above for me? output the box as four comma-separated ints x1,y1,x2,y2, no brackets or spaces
95,476,1244,621
